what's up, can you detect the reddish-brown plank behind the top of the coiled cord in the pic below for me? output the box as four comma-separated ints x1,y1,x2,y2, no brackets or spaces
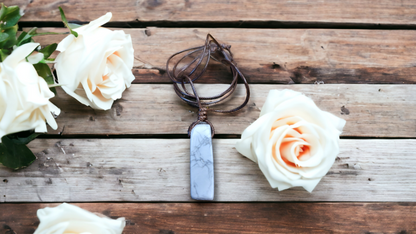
35,27,416,84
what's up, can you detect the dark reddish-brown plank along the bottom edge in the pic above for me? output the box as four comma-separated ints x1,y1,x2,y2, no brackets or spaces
0,203,416,234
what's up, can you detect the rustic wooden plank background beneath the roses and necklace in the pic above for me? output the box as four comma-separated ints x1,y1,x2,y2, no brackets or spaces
0,0,416,233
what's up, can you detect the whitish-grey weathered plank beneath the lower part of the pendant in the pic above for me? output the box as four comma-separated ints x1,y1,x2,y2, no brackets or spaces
0,139,416,202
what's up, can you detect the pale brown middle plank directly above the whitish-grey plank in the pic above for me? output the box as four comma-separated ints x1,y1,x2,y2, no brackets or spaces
45,84,416,137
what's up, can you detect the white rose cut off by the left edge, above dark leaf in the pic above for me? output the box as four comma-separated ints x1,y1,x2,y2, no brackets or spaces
0,43,60,142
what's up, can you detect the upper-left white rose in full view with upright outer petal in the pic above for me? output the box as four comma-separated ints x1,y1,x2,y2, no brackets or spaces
55,13,134,110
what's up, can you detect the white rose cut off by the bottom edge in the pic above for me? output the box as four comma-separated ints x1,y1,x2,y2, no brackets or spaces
34,203,126,234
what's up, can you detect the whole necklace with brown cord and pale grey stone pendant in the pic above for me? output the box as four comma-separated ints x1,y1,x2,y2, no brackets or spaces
166,34,250,200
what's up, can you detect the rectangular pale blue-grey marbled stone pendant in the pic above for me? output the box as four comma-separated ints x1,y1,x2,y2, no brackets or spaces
190,123,214,200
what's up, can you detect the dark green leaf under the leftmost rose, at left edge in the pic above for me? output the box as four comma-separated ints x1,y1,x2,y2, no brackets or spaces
0,133,38,170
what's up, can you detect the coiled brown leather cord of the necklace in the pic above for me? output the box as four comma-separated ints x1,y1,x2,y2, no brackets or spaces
166,34,250,137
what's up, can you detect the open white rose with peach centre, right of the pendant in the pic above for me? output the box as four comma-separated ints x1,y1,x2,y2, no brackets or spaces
236,89,345,192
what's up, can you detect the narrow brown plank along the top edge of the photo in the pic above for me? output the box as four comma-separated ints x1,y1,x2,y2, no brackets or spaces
5,0,416,25
